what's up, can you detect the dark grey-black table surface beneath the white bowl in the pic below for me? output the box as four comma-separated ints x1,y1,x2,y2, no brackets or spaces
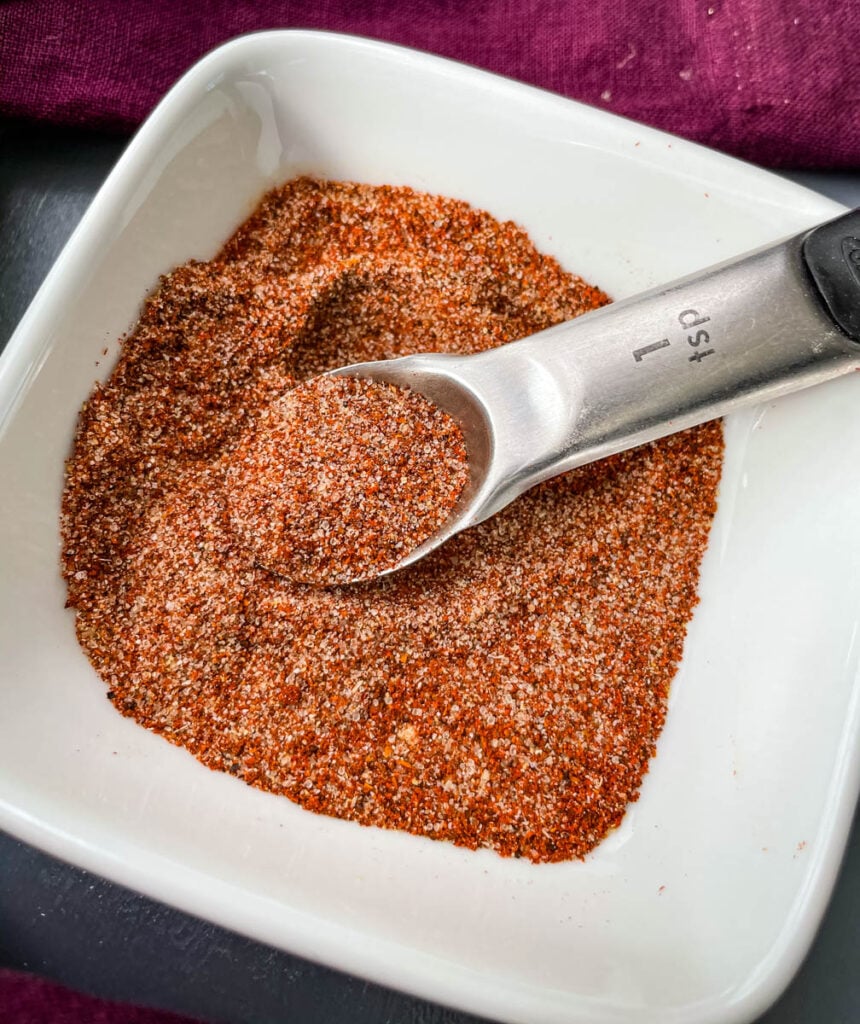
0,116,860,1024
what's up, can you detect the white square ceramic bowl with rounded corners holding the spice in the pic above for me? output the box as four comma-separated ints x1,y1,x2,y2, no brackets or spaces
0,32,860,1024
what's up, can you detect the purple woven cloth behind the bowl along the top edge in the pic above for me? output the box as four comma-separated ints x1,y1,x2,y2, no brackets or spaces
0,0,860,168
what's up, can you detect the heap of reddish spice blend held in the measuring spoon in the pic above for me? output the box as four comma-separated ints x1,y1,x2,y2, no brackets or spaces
226,377,469,585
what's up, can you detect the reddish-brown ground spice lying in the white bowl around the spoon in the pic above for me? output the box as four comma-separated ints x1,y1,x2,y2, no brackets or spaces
62,179,723,861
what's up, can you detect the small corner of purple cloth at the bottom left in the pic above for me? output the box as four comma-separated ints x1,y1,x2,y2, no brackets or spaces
0,971,203,1024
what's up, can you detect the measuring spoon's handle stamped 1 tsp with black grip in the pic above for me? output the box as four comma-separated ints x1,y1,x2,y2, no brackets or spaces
482,211,860,517
